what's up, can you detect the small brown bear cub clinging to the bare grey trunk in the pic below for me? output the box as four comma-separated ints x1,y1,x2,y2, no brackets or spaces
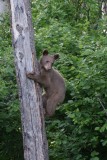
27,50,65,117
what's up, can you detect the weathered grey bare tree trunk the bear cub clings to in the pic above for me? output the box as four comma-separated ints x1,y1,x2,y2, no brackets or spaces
10,0,48,160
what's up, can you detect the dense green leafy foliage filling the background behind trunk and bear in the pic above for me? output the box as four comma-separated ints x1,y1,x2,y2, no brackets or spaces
0,0,107,160
